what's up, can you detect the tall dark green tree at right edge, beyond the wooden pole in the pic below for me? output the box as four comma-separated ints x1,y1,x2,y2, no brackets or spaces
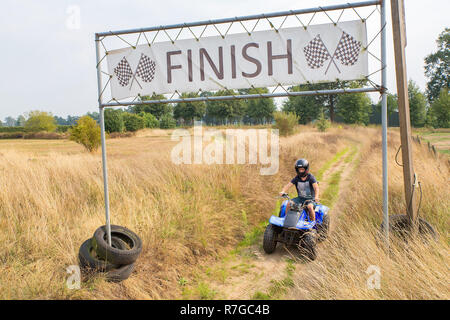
425,28,450,104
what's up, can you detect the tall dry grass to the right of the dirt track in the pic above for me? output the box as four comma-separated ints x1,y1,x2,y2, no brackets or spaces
287,126,450,299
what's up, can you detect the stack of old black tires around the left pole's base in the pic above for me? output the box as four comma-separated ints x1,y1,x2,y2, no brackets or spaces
78,225,142,282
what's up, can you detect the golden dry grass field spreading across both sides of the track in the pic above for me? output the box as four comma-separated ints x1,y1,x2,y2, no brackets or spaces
0,126,450,299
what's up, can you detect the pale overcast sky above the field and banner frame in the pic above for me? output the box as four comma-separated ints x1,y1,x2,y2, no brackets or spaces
0,0,450,121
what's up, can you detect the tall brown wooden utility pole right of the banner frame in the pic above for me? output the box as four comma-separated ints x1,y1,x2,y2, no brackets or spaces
391,0,417,231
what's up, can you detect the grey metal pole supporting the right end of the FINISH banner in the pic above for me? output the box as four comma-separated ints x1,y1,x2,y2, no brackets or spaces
381,0,389,248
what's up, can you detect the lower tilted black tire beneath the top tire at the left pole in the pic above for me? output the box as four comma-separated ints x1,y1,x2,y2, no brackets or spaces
78,238,125,272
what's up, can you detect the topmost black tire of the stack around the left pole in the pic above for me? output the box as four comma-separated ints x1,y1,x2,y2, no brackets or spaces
92,225,142,265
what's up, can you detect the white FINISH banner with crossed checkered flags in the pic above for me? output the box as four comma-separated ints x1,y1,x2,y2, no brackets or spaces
107,20,368,99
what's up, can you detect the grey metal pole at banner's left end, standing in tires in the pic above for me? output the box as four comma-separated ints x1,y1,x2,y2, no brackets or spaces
95,34,111,245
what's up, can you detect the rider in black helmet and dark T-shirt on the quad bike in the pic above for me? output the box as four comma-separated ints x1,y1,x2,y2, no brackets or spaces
280,159,319,221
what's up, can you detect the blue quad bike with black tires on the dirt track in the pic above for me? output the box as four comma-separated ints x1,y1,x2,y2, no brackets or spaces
263,194,330,260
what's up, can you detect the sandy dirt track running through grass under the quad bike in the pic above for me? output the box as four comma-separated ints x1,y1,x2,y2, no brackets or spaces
186,140,359,299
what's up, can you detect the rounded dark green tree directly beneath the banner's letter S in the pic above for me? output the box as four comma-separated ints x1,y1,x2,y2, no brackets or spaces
242,88,276,124
